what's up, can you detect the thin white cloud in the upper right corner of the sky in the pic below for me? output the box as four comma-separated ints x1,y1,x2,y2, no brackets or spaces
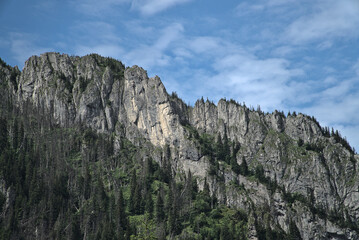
285,0,359,44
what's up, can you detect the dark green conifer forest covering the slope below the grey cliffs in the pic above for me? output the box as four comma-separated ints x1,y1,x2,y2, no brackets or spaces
0,91,255,239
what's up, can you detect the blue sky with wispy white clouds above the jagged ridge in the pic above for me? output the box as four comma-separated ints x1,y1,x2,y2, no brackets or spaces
0,0,359,150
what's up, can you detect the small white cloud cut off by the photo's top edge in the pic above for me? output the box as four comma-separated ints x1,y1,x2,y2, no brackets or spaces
131,0,191,16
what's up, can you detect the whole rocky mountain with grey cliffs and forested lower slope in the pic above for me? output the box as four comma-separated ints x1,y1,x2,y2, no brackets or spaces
0,53,359,239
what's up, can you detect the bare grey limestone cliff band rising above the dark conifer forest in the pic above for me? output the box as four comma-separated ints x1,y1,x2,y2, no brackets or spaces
0,53,359,239
